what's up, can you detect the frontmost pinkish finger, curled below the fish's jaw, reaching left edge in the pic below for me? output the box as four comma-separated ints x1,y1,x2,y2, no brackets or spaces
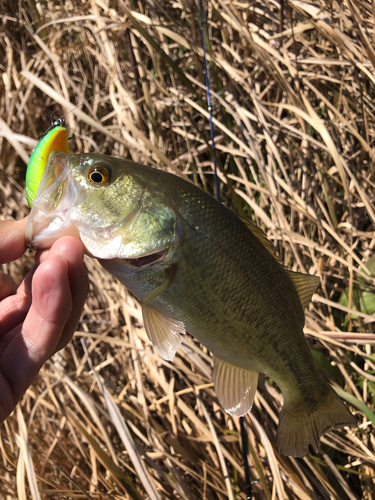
0,257,73,420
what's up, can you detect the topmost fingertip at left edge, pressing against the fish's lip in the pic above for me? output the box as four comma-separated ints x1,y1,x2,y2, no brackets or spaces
0,218,27,264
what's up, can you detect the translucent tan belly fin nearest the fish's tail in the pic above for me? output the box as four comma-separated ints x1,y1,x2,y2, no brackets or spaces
213,356,258,417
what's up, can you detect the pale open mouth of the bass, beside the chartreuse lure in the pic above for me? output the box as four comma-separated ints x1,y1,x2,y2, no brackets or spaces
25,151,83,249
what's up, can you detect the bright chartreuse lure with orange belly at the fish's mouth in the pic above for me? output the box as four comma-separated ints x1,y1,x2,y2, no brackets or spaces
25,118,69,208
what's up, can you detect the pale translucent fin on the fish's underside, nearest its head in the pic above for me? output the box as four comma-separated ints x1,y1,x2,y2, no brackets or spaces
142,304,185,361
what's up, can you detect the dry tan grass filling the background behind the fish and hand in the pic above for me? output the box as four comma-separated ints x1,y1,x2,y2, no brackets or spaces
0,0,375,500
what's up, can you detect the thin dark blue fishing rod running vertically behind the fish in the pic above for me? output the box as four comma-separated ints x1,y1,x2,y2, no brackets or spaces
198,0,253,500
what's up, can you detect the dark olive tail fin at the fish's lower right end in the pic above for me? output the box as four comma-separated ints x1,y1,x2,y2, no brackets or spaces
276,383,356,457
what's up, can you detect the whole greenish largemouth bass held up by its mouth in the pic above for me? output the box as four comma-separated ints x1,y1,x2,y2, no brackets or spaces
26,151,356,456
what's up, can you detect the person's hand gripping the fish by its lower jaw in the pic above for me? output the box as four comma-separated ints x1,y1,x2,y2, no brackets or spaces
0,219,88,422
